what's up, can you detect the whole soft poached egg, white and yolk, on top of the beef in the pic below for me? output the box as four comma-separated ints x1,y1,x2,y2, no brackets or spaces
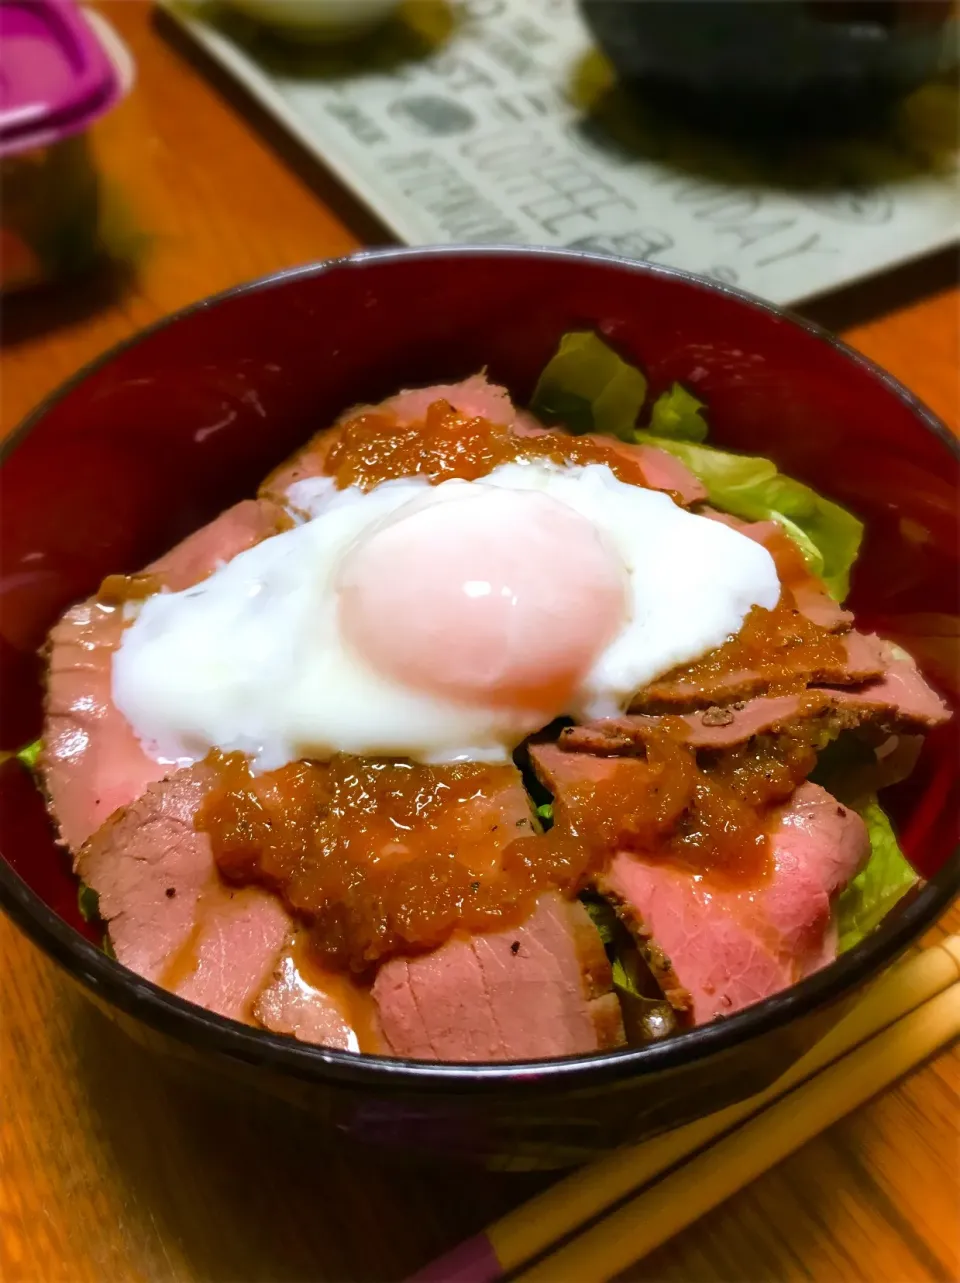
113,462,780,770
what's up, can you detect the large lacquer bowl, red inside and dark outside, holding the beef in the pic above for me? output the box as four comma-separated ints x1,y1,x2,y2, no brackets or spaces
0,248,960,1166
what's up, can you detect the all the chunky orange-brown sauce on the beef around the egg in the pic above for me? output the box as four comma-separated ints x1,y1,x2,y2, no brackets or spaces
196,402,844,964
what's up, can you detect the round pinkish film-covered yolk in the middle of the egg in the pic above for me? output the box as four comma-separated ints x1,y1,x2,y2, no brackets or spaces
339,486,626,717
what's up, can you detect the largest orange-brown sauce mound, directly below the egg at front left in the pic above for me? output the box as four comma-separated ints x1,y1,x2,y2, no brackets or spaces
196,753,551,971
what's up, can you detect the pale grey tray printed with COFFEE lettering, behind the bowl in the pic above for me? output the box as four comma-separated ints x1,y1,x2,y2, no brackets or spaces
162,0,957,305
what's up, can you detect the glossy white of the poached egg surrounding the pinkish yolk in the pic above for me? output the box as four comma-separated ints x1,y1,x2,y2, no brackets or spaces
113,462,780,770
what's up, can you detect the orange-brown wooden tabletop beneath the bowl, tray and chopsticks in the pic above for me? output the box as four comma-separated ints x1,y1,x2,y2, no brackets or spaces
0,0,960,1283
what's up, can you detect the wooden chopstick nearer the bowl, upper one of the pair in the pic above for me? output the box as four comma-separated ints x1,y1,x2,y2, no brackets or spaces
411,935,960,1283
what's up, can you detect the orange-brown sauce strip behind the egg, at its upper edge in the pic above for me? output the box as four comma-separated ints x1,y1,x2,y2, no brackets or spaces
325,402,662,490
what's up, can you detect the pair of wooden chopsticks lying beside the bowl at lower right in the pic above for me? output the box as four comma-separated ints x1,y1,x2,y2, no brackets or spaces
408,935,960,1283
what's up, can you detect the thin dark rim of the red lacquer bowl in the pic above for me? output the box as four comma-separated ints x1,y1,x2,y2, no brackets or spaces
0,245,960,1096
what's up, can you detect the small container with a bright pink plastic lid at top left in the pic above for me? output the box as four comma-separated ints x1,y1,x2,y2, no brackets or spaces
0,0,132,291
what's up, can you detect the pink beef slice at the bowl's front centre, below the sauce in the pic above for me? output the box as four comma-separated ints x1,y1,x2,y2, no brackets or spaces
373,893,624,1061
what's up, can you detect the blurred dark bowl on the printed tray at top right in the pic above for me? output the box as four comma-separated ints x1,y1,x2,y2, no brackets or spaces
580,0,957,135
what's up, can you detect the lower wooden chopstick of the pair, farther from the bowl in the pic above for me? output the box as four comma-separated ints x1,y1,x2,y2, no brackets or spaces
516,983,960,1283
